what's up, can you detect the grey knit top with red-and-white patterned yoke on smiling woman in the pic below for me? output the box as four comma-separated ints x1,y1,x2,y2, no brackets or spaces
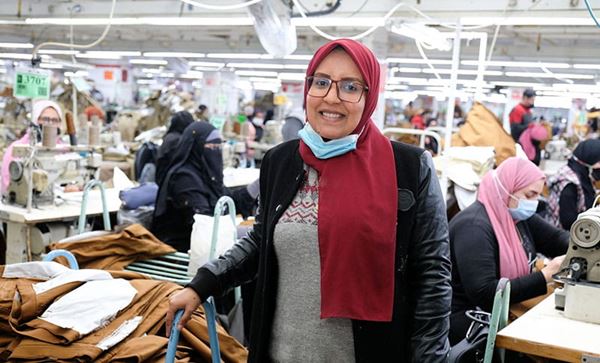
270,167,355,363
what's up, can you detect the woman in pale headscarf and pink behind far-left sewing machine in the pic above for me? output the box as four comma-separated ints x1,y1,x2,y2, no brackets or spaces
0,100,62,195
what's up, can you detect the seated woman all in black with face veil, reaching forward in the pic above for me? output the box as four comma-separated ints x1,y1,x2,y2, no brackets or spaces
151,122,258,252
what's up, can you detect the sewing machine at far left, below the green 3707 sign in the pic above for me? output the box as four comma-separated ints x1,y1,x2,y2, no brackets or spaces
6,145,102,206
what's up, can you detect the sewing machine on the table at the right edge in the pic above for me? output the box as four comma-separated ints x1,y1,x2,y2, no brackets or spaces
555,207,600,324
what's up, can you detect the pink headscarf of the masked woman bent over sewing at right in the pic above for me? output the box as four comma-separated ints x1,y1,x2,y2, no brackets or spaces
477,157,546,279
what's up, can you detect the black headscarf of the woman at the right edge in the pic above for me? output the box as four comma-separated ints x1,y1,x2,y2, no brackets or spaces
568,139,600,208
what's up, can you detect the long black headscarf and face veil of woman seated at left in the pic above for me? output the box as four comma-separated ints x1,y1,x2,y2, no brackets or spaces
154,122,224,218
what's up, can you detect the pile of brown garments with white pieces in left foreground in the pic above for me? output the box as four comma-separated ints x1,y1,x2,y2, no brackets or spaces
0,262,247,362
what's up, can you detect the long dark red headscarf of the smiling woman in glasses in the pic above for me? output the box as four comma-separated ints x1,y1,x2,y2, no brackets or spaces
300,39,398,321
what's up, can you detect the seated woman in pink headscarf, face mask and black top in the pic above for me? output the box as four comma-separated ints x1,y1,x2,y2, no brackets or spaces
449,157,569,345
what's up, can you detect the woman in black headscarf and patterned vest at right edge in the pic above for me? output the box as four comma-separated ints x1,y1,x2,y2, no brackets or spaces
546,139,600,230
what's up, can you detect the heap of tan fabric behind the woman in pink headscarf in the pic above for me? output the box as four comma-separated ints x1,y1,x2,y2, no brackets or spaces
452,102,516,166
